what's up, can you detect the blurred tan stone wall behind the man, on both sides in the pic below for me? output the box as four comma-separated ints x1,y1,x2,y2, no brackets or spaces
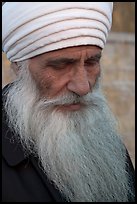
2,2,135,166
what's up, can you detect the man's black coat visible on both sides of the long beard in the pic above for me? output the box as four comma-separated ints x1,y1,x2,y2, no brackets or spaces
2,83,134,202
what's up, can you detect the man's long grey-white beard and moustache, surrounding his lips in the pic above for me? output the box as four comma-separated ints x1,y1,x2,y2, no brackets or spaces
5,60,132,202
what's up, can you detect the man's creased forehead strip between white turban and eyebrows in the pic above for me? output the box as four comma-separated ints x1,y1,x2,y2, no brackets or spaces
32,45,102,60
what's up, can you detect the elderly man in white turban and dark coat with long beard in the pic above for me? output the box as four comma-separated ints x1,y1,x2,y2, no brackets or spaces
2,2,135,202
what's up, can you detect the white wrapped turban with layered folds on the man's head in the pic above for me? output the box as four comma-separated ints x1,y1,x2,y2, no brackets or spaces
2,2,113,62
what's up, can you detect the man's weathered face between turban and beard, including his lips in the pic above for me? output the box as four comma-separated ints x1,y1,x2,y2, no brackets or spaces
29,46,101,111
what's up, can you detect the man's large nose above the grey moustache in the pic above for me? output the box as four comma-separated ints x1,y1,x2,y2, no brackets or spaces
67,67,91,96
